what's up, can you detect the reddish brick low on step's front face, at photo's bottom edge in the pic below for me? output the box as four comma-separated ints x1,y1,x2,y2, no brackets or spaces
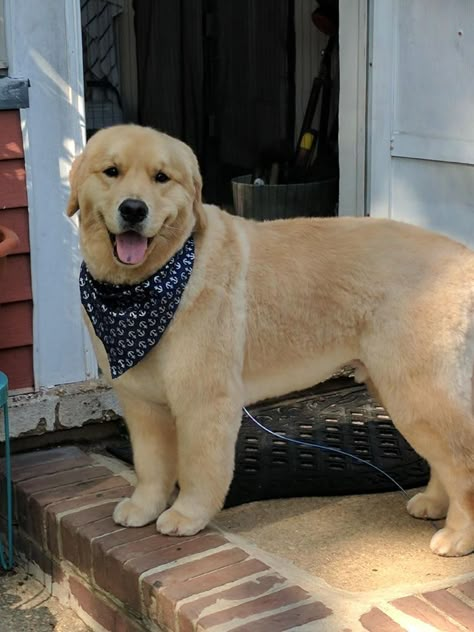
69,577,147,632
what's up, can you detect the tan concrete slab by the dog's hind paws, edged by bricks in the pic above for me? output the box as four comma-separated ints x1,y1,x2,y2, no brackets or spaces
215,490,474,594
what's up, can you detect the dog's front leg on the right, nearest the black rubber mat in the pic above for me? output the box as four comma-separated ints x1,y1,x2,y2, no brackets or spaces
156,396,242,535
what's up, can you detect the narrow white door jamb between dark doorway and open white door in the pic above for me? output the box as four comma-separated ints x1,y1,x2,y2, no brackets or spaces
339,0,368,216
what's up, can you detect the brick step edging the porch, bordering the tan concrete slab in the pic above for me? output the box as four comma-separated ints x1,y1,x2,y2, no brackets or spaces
2,447,474,632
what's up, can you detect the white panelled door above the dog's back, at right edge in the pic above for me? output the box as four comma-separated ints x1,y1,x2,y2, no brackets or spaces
367,0,474,247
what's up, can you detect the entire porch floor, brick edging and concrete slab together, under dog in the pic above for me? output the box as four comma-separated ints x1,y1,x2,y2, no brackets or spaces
1,448,474,632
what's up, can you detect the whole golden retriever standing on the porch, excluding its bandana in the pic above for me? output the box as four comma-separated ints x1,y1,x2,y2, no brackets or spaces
67,125,474,556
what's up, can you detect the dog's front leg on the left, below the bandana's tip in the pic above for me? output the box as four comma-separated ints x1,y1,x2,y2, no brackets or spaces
113,393,176,527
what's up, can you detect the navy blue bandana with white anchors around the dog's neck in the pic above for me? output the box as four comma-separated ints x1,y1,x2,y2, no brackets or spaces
79,237,194,378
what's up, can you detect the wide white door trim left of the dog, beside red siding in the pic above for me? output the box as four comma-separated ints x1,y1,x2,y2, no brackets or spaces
5,0,97,388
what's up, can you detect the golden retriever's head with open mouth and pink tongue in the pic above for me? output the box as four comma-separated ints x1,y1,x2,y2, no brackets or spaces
67,125,205,283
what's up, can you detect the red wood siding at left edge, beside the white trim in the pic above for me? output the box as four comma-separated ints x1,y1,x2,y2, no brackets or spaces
0,110,34,389
